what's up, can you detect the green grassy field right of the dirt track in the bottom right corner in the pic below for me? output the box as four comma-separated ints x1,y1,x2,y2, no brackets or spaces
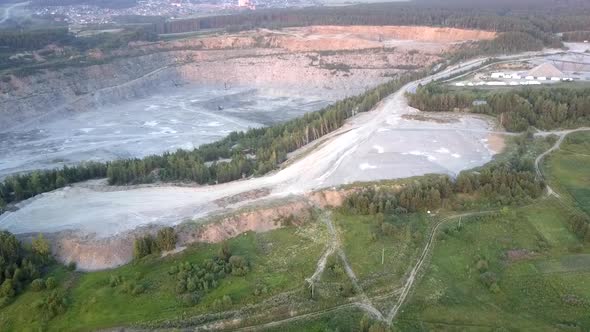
396,201,590,331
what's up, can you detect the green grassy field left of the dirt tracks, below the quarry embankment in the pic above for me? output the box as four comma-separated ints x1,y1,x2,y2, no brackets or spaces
0,223,326,331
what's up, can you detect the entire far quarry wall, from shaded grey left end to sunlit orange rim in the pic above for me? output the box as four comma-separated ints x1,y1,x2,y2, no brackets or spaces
0,26,495,130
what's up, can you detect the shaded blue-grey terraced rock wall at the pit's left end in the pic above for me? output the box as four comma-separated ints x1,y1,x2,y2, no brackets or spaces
0,54,183,130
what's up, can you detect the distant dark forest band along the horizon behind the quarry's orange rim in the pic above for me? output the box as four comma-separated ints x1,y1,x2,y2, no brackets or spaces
155,0,590,33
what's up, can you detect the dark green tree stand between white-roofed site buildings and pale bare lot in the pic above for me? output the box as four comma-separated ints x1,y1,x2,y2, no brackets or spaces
408,83,590,132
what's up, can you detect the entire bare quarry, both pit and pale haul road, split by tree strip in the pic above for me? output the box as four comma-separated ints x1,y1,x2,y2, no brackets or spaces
0,27,503,270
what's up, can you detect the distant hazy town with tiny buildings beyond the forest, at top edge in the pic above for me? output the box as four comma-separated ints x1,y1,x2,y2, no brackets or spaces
32,0,321,25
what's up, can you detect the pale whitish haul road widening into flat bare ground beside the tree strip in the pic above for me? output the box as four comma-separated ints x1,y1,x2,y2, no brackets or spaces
0,50,564,238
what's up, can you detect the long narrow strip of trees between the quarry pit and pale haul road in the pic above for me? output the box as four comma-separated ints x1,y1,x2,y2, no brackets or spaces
0,72,425,212
